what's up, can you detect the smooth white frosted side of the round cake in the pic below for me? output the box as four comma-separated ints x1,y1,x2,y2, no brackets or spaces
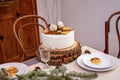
41,30,75,49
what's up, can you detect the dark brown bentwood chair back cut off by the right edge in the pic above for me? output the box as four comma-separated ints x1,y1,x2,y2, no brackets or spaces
104,11,120,58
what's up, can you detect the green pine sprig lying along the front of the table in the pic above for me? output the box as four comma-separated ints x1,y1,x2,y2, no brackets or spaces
0,66,98,80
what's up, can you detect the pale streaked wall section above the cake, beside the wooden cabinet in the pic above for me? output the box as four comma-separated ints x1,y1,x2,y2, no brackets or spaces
37,0,61,24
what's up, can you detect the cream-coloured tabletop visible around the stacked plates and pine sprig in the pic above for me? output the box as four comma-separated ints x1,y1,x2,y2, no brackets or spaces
25,46,120,80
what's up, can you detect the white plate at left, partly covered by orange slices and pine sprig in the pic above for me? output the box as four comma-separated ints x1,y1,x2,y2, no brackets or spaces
0,62,28,75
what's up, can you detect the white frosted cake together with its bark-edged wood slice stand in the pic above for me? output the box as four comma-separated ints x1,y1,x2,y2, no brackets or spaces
37,22,81,66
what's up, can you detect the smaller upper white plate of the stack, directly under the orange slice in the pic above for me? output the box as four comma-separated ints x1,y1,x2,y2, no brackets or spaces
82,53,116,68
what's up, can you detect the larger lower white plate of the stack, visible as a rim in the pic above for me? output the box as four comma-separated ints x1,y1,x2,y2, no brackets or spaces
76,54,118,72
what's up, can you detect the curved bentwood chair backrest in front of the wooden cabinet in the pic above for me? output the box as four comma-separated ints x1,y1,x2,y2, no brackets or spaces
13,15,48,61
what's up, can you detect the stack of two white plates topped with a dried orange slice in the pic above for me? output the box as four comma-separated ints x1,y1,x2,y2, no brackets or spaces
76,53,118,72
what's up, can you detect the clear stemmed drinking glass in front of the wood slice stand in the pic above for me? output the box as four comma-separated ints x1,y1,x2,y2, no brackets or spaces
39,45,51,69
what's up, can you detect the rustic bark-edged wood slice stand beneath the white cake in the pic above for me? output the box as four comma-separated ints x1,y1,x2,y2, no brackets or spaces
36,41,82,66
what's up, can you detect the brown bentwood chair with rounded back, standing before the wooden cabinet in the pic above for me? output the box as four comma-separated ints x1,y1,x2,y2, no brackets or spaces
13,15,48,62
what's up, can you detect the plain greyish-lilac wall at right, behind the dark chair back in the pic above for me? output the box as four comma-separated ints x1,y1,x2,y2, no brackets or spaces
61,0,120,56
